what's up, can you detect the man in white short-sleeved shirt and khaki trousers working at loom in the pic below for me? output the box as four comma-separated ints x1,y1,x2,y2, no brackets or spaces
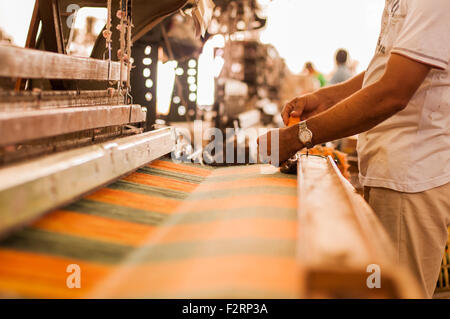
260,0,450,297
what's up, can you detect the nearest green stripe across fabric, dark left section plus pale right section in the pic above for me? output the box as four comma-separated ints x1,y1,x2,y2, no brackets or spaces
0,228,296,264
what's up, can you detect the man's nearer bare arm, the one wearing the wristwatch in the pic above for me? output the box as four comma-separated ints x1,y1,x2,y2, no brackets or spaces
269,54,431,162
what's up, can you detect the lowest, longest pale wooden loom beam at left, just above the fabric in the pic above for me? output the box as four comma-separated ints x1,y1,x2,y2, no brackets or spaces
0,128,175,238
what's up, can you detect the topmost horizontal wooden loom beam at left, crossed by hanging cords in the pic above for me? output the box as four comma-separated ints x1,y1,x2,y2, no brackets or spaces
0,44,127,81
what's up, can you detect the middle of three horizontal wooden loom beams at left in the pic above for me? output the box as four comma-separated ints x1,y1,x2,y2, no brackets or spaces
0,105,147,145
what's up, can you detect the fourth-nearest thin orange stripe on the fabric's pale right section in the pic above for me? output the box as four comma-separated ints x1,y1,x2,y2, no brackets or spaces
197,177,297,192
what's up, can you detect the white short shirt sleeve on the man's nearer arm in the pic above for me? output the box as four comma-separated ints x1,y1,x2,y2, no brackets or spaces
391,0,450,70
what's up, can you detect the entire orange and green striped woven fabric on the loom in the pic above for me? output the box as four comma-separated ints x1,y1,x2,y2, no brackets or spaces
0,160,298,298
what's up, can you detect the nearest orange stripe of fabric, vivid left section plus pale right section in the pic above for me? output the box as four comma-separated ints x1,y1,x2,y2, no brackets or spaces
0,250,299,298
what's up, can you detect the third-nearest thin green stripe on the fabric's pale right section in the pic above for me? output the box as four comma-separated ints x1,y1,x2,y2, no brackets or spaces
188,188,297,201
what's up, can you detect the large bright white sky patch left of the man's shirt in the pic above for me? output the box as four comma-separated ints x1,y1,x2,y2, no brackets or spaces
261,0,385,74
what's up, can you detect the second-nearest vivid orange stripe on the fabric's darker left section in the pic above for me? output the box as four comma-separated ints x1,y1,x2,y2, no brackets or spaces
32,210,155,246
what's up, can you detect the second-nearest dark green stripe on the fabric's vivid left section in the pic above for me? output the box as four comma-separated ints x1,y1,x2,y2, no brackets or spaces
64,199,168,225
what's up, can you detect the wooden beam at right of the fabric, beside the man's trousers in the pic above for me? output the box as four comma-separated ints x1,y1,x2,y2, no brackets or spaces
297,156,422,298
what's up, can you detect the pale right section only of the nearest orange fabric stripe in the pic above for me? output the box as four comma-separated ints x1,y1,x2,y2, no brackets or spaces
93,255,300,298
